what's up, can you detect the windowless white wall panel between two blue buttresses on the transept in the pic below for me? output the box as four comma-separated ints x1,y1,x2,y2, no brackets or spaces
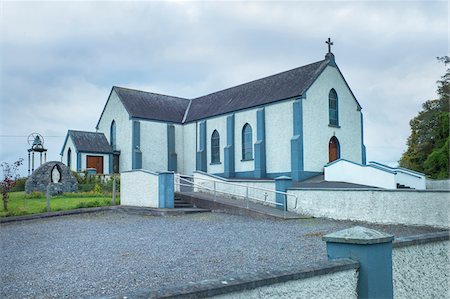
140,120,168,171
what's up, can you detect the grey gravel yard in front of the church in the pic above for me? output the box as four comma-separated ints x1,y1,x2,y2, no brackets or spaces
0,212,442,298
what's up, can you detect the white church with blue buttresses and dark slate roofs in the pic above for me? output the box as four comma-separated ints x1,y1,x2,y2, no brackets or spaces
61,50,366,181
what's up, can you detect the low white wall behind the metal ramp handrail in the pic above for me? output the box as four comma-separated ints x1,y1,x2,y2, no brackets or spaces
194,172,275,204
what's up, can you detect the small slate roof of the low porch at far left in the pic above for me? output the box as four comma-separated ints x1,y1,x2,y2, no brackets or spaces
67,130,113,154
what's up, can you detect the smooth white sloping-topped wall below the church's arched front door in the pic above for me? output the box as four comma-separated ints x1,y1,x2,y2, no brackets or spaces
324,160,397,189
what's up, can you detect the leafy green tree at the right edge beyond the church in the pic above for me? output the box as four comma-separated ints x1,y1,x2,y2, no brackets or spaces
399,56,450,179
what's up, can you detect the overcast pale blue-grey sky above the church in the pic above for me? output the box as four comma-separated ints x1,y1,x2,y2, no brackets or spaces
0,1,449,173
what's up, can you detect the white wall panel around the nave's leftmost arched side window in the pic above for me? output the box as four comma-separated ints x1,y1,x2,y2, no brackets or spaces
206,115,227,173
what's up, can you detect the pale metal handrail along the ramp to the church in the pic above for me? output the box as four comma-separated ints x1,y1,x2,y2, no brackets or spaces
177,175,298,210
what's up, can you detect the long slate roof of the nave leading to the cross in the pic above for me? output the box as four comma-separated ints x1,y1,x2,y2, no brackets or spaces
185,59,329,122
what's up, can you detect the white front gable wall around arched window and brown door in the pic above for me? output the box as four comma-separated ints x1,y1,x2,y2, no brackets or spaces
303,66,362,172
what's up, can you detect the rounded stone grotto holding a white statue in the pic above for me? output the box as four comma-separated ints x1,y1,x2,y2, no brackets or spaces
25,161,78,195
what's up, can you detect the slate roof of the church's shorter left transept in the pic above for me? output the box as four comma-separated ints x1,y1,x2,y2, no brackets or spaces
113,86,189,123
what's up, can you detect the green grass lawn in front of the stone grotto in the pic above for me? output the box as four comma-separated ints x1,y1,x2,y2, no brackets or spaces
0,192,120,217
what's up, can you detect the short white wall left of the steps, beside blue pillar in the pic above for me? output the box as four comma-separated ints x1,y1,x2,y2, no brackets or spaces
120,170,159,208
